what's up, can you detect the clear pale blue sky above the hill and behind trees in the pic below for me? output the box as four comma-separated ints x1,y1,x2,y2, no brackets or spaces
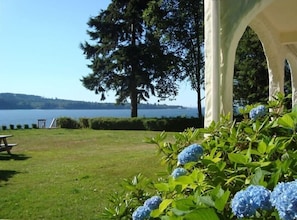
0,0,196,107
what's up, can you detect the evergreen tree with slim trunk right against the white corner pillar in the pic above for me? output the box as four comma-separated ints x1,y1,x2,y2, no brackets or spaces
146,0,204,118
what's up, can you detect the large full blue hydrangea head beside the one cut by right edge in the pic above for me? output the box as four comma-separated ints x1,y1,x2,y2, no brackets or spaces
231,185,271,218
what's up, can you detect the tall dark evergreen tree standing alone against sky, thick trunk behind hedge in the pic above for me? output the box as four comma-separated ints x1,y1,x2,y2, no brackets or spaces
81,0,180,117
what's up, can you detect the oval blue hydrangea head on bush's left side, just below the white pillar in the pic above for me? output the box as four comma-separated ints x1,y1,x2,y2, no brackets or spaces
177,144,203,165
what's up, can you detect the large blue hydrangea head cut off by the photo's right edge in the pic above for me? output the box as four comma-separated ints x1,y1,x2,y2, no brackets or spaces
270,180,297,220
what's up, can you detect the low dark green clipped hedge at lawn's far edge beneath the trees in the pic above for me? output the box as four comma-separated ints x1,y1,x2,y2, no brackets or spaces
57,117,203,131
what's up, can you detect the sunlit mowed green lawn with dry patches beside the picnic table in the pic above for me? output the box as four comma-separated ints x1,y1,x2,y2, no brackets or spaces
0,129,171,220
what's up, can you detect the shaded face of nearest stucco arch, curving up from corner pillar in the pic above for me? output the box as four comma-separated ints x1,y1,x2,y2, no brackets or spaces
220,0,273,117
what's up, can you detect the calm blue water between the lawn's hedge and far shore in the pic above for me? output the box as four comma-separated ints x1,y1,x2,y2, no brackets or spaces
0,108,197,127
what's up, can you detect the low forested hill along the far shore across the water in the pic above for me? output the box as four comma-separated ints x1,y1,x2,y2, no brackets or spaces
0,93,181,109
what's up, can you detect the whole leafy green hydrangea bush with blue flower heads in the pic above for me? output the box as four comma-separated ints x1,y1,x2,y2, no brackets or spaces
104,93,297,220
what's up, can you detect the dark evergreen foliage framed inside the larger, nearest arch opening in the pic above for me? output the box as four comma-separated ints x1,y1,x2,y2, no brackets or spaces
233,27,269,106
